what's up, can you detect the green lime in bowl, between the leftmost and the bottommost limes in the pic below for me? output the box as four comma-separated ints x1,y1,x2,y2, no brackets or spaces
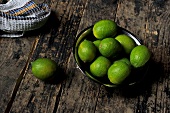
90,56,111,77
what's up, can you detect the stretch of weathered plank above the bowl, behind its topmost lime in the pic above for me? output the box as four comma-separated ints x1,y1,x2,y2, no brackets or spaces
78,0,117,33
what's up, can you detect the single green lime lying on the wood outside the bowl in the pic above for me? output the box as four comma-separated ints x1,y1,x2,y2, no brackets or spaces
31,58,58,80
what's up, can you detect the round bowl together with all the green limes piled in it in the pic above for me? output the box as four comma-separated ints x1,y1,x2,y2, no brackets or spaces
73,20,151,87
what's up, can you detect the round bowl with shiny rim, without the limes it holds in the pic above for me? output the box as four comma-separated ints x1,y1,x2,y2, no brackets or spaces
73,26,148,87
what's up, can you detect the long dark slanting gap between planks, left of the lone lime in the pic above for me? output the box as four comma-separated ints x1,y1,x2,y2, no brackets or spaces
5,38,39,113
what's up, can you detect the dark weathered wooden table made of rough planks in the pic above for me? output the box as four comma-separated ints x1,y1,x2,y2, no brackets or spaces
0,0,170,113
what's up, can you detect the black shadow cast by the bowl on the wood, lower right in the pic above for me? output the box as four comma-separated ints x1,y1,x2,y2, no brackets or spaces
106,60,164,98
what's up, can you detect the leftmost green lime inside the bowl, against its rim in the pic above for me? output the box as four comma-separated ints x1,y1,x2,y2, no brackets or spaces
78,40,96,62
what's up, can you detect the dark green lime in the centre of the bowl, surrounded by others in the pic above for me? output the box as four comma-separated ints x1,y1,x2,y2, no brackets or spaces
99,38,122,58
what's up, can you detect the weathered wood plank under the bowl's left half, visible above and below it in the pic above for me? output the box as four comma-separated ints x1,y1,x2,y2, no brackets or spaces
56,0,116,113
